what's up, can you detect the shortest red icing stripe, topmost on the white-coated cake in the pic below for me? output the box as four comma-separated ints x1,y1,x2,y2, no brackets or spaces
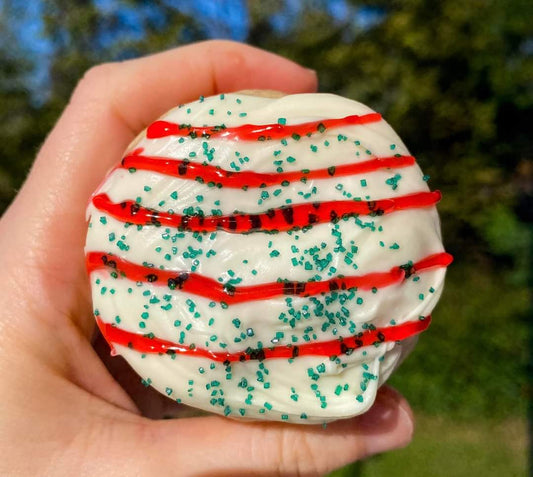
146,113,381,141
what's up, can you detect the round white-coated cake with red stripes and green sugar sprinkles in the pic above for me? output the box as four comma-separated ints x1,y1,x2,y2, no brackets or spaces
86,92,451,423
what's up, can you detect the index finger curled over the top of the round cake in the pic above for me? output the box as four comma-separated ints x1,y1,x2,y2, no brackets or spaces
9,41,316,219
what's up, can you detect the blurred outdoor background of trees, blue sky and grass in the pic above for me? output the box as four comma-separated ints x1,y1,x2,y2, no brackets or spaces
0,0,533,477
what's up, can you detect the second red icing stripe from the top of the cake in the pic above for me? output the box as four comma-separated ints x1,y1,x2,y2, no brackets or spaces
122,154,415,189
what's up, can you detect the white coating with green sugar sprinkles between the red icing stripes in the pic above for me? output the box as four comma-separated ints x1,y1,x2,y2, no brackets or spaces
86,93,445,423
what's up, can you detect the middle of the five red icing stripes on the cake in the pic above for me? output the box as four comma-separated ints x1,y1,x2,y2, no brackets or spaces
92,191,441,233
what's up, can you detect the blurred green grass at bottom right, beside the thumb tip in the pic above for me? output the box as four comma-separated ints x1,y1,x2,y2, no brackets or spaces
331,415,527,477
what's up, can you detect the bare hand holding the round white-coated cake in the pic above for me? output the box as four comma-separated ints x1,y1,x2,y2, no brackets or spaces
0,41,413,476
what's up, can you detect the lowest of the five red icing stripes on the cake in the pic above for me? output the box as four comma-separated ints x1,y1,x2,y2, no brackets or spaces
96,316,431,363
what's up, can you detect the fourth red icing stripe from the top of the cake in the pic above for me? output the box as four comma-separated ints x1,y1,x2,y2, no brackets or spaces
86,252,452,305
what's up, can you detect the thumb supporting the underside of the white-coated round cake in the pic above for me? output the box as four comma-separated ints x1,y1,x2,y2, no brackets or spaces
108,387,413,476
